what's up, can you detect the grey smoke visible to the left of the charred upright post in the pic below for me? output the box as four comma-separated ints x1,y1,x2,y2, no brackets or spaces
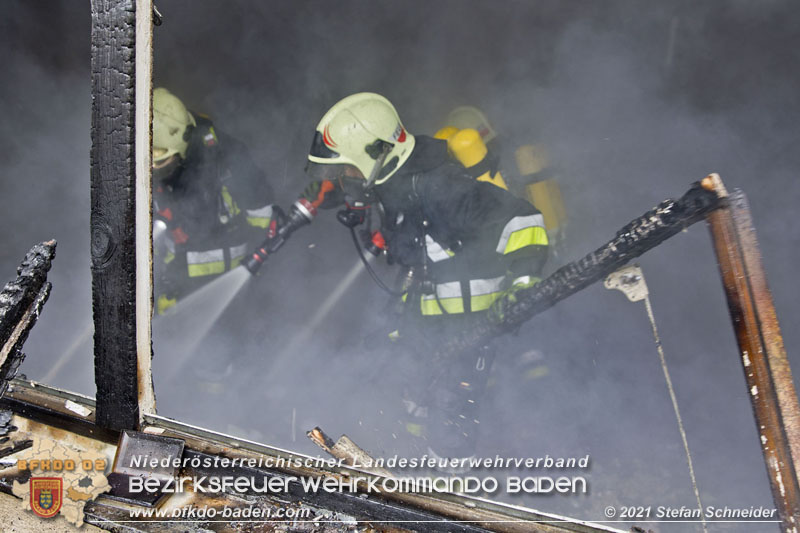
0,2,94,394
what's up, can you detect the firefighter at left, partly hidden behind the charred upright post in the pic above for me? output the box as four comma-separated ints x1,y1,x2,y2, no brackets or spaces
153,88,272,314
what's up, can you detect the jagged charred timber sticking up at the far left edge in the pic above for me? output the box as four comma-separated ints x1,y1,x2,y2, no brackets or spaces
0,241,56,397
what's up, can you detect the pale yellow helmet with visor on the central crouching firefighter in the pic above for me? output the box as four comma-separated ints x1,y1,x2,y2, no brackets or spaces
307,93,415,185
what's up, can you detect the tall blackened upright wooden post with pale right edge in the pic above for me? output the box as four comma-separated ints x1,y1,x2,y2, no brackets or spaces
91,0,152,430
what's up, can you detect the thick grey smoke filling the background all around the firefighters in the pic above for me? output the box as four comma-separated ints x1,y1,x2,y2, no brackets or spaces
0,0,800,531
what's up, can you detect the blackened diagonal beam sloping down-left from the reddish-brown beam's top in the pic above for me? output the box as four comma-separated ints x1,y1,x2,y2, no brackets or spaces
435,176,721,362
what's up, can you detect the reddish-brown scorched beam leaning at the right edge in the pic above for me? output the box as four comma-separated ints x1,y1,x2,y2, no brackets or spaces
709,184,800,532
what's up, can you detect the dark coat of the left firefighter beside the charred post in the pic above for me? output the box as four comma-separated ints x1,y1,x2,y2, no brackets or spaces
153,115,272,298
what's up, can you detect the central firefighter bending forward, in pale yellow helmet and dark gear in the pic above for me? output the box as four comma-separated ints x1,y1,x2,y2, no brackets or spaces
301,93,548,458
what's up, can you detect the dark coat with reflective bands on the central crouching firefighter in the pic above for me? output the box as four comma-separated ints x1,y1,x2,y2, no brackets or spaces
375,136,547,315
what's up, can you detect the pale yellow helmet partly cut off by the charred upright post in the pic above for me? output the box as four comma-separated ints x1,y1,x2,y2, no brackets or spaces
153,87,197,166
